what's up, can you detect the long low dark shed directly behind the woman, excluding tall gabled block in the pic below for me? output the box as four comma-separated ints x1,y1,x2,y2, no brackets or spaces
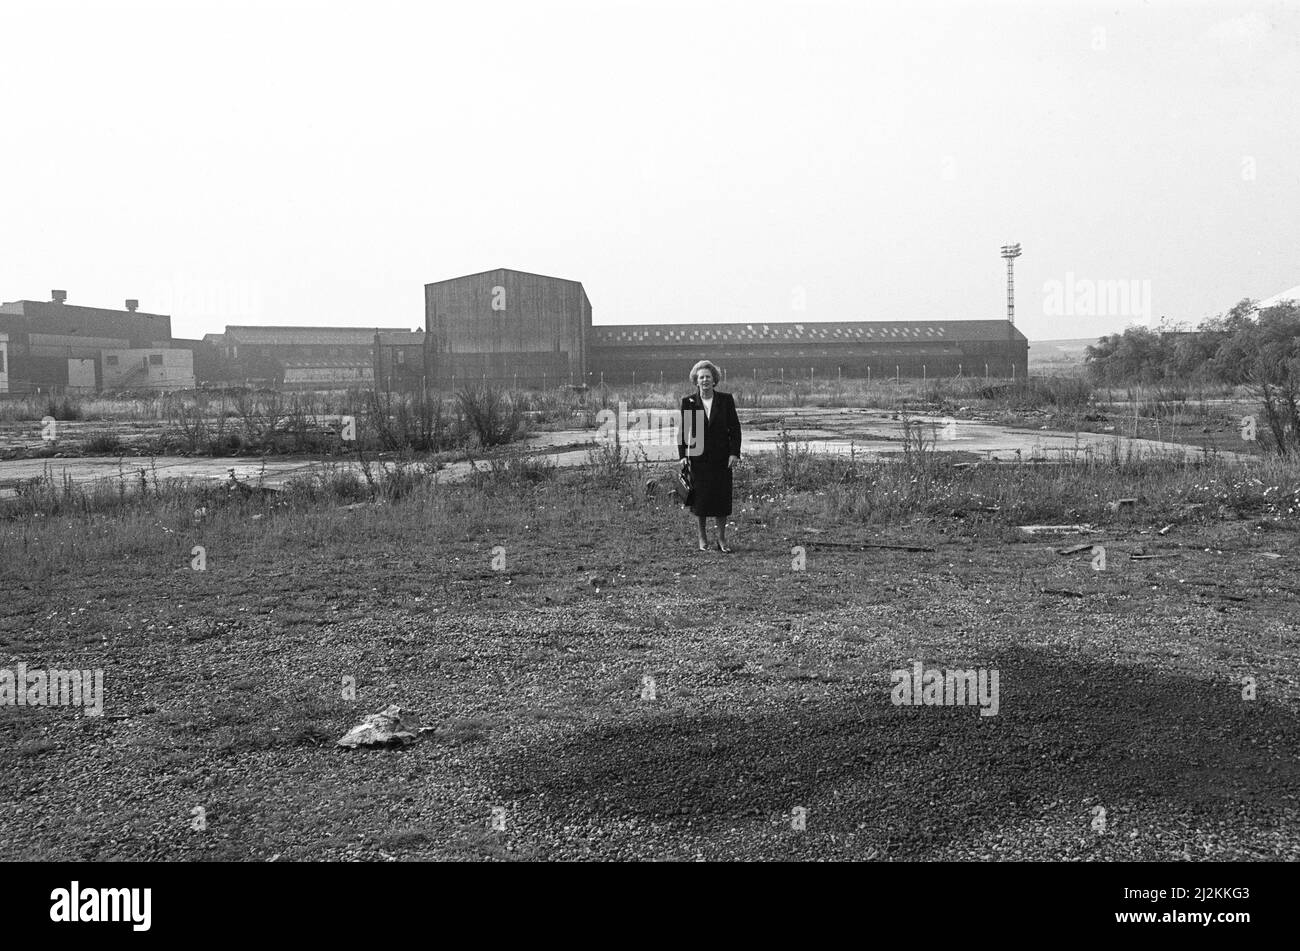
590,321,1028,386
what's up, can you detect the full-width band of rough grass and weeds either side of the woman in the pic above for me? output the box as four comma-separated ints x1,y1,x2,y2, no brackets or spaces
0,439,1300,577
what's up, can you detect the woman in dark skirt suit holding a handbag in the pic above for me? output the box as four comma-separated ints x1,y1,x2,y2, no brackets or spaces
677,360,740,553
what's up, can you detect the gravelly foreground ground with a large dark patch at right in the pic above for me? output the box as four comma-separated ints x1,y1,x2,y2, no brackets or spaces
0,475,1300,860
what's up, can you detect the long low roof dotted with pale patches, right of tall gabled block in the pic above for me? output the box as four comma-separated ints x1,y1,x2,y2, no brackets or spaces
592,321,1024,347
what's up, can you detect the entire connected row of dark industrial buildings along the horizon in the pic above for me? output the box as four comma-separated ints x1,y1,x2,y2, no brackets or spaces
0,275,1028,394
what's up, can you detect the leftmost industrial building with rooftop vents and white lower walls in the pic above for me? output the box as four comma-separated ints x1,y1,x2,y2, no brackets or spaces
0,291,194,394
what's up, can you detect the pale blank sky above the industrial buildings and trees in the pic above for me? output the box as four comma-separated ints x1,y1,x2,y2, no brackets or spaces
0,0,1300,339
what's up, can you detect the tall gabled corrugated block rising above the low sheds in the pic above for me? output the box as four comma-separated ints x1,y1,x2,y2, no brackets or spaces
424,268,592,387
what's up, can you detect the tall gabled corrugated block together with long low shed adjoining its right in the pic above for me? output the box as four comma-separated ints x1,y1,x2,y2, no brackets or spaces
425,268,1028,387
